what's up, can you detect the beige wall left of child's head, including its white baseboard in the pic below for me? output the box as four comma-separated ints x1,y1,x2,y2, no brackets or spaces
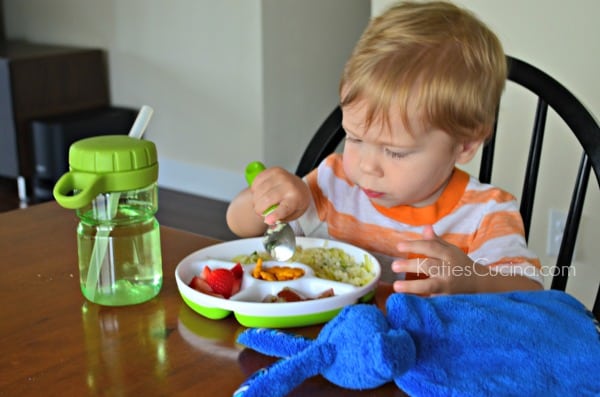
4,0,370,200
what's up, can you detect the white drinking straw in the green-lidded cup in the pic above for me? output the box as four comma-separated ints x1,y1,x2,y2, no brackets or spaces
85,105,154,300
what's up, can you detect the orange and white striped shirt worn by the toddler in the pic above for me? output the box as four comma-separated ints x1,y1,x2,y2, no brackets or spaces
291,153,542,283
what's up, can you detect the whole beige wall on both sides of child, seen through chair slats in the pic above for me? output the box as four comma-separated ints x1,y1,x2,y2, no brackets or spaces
4,0,600,305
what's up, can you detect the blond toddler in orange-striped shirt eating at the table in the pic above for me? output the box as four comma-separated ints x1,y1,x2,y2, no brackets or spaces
227,2,542,295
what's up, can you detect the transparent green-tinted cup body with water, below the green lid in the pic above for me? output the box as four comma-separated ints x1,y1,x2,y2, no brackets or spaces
77,187,162,306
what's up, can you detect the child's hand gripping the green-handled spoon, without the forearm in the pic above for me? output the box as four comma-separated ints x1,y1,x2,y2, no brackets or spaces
250,167,310,225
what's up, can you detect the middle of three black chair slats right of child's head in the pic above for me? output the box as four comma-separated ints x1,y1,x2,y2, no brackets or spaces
520,98,548,241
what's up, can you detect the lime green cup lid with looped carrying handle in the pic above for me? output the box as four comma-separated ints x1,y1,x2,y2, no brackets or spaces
53,135,158,209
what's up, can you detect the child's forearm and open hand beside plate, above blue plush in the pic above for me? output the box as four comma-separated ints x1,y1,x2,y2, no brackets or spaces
392,226,543,295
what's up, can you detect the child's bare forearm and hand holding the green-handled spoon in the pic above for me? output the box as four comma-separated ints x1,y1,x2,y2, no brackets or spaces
227,167,310,237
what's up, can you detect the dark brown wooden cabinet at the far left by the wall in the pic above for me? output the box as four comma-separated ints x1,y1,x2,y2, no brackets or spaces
0,40,110,194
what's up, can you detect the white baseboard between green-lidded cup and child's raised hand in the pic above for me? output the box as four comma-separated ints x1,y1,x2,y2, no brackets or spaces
158,156,246,202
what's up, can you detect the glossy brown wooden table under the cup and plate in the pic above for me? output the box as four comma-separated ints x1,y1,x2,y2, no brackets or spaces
0,202,404,397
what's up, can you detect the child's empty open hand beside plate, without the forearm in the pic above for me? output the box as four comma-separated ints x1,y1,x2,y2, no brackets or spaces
392,226,487,295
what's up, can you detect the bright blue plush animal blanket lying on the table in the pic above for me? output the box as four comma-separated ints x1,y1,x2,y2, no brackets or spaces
234,291,600,397
